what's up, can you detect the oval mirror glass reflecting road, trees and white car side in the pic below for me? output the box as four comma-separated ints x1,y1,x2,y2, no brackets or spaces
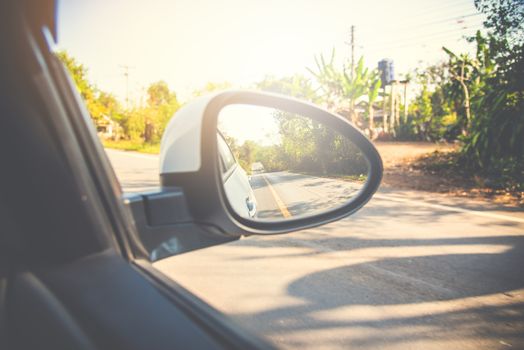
218,104,368,221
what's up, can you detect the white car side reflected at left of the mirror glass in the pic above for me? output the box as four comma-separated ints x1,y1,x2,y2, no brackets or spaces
217,133,257,218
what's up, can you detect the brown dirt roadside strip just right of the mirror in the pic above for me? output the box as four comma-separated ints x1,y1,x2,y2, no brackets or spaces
375,142,524,208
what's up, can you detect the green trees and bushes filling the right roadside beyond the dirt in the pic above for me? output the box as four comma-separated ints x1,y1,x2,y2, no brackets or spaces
410,0,524,183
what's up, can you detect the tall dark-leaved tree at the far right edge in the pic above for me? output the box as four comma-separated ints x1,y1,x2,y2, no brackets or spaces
462,0,524,172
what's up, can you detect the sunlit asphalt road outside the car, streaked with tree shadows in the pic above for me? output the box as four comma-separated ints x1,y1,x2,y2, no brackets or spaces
108,151,524,349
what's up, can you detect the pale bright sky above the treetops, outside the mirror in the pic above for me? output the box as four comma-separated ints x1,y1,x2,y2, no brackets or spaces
57,0,484,104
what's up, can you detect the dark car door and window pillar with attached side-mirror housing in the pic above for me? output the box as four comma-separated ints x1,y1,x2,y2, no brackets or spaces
0,0,382,349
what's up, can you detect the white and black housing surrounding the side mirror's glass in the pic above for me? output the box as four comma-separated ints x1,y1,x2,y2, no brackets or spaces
160,91,383,237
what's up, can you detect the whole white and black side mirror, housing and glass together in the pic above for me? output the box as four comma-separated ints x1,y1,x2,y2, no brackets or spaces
160,91,382,236
